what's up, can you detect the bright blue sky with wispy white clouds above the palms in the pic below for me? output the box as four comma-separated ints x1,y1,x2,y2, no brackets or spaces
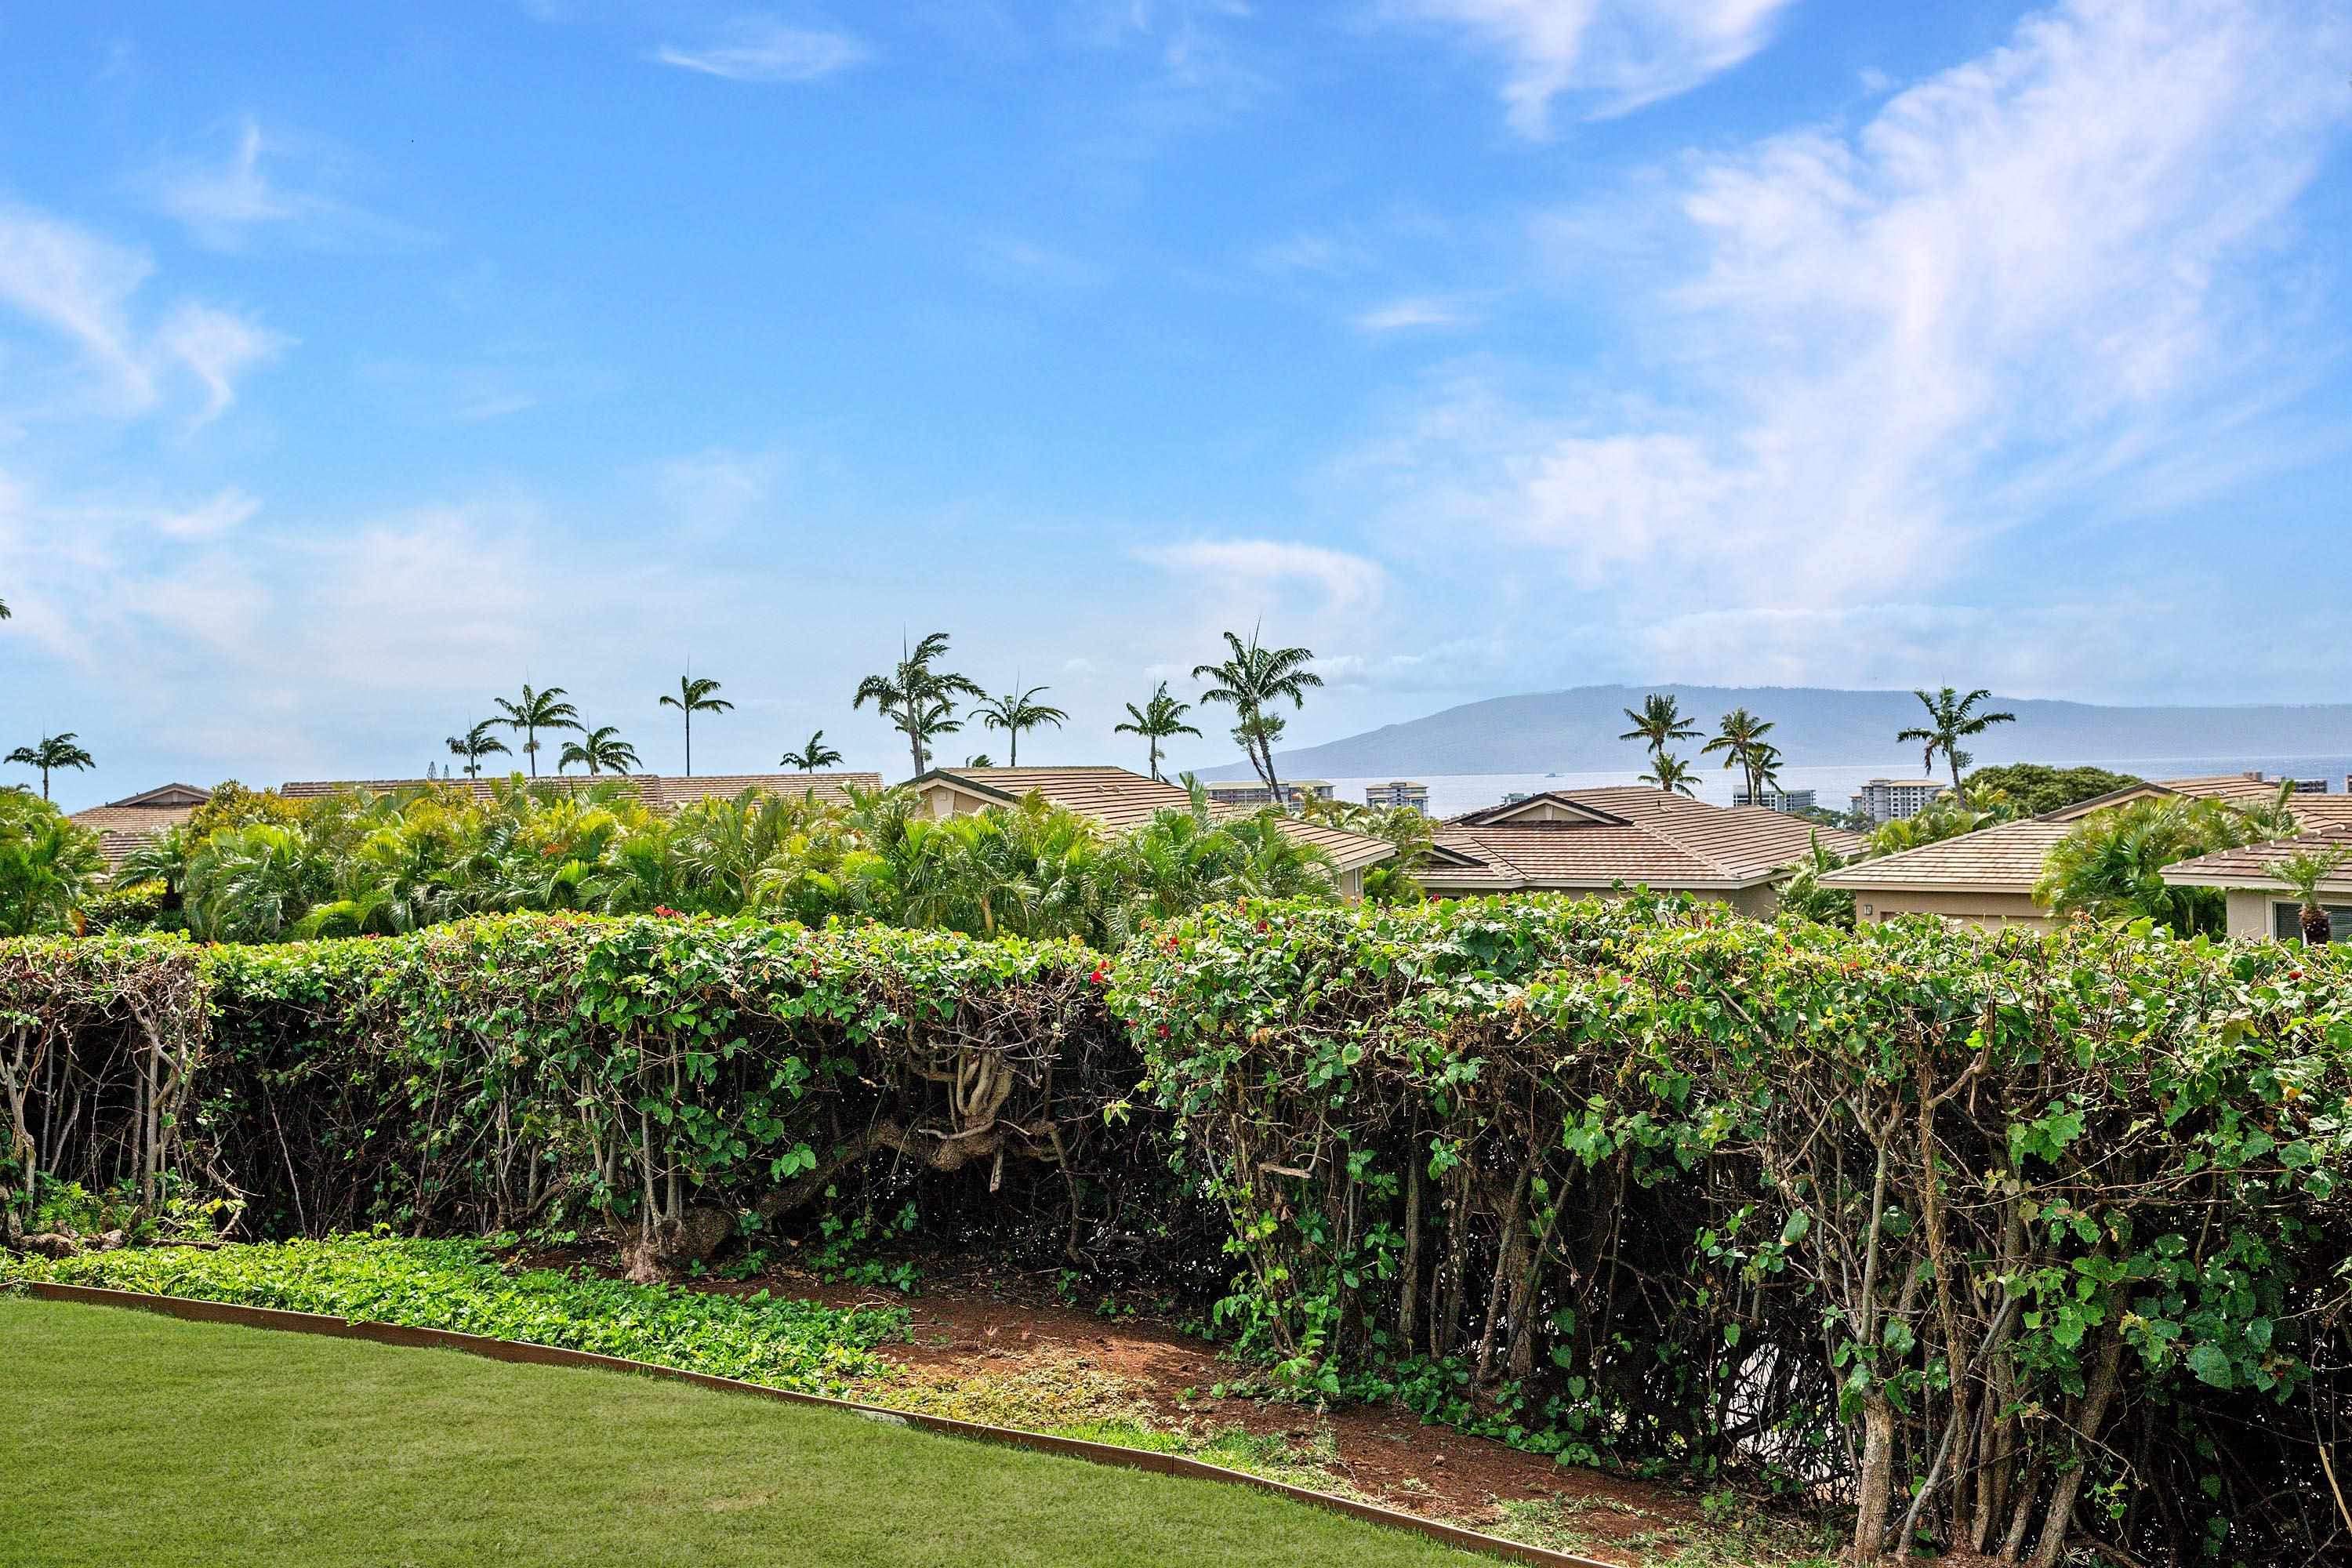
0,0,2352,804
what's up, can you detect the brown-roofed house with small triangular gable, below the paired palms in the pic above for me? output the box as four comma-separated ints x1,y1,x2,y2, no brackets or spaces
1414,785,1860,916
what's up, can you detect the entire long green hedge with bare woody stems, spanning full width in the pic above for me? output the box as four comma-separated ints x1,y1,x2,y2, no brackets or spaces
0,898,2352,1563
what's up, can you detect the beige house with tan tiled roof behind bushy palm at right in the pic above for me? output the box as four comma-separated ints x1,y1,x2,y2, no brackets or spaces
1820,774,2352,926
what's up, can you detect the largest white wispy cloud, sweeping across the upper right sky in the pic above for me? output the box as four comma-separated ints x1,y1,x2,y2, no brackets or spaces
1376,0,2352,673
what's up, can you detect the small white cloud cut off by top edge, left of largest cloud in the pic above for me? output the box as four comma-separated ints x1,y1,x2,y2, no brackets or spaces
1385,0,1790,136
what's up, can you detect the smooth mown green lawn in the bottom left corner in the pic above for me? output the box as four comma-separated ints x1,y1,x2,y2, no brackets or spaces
0,1295,1482,1568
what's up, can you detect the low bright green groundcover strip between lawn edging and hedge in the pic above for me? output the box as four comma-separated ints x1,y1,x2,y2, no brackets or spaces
0,1236,906,1394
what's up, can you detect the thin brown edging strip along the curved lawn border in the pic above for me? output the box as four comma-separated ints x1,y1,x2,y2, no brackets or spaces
19,1279,1618,1568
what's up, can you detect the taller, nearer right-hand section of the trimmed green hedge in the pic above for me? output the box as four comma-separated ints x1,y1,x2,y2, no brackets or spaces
1115,907,2352,1563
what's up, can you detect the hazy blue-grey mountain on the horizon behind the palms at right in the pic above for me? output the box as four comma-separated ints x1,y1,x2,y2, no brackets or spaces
1202,684,2352,779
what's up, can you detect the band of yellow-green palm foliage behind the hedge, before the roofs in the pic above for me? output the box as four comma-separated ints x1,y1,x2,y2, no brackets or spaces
122,781,1331,945
